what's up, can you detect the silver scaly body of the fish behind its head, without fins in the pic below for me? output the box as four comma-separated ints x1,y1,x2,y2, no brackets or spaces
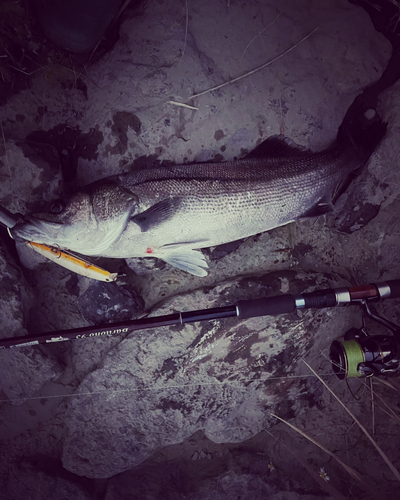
103,143,360,256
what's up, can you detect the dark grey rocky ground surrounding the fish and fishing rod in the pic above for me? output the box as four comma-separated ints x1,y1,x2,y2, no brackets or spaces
0,0,400,500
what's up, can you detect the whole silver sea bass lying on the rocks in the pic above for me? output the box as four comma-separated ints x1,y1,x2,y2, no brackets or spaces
11,110,386,276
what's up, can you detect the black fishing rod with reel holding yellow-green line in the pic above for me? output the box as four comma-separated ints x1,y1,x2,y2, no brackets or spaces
0,279,400,379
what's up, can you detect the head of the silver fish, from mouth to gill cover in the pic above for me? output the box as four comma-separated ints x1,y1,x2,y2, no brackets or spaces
11,181,138,255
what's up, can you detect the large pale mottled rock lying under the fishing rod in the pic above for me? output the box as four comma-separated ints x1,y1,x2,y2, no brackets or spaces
63,271,357,478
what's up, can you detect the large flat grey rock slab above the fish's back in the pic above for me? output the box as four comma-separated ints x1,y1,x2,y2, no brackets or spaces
0,0,391,183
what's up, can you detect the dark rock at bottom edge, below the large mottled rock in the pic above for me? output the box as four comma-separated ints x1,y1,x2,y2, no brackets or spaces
107,434,326,500
